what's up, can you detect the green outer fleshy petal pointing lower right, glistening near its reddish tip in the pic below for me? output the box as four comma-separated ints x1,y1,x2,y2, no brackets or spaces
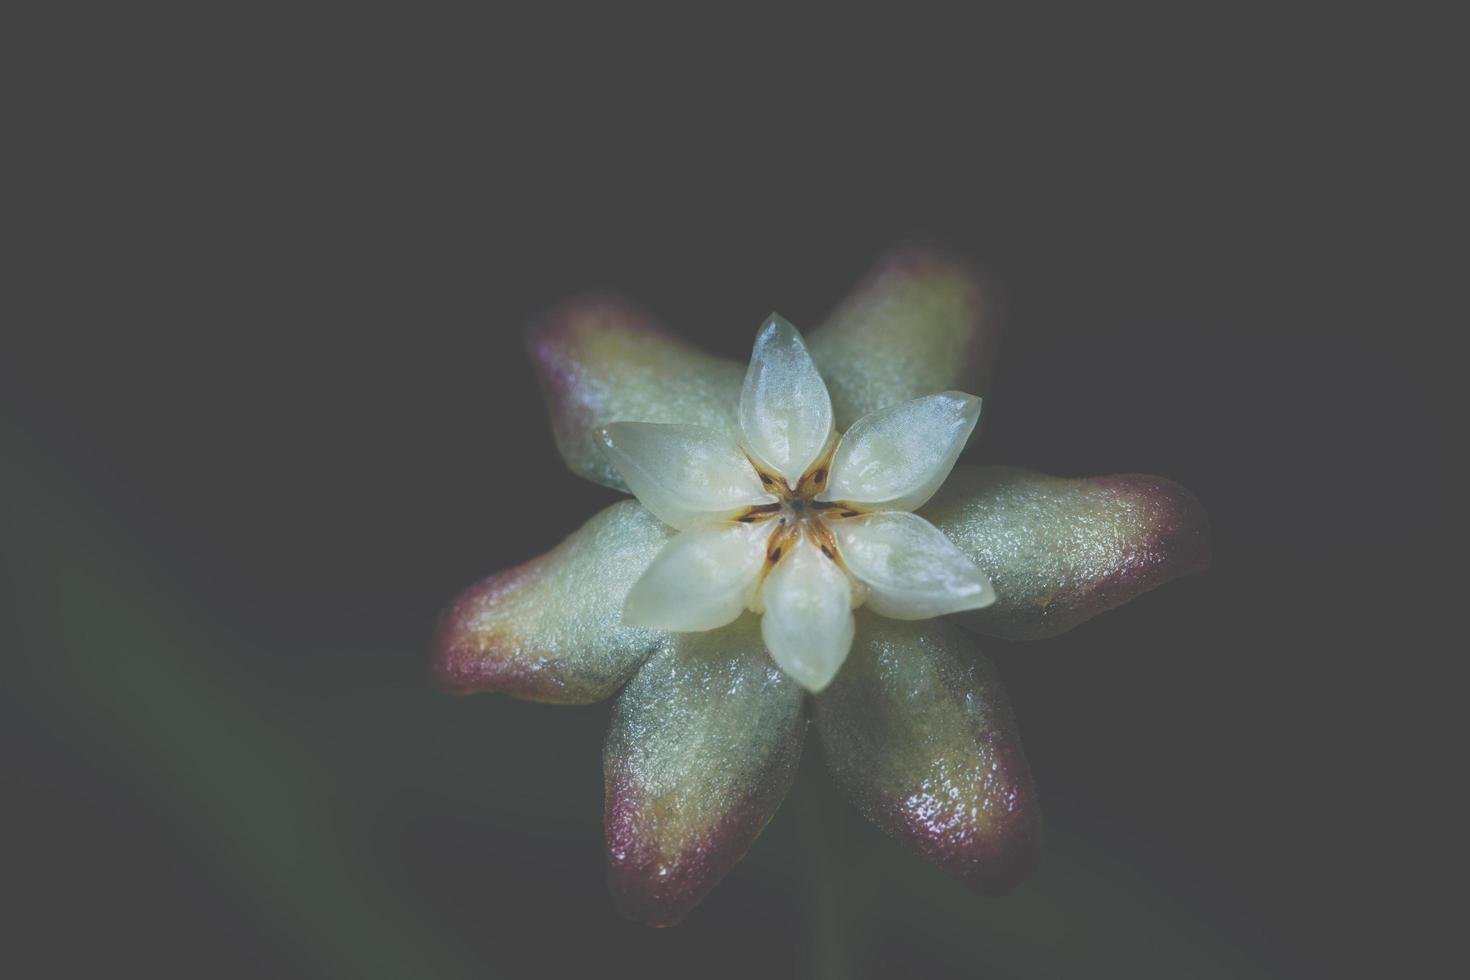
813,613,1041,895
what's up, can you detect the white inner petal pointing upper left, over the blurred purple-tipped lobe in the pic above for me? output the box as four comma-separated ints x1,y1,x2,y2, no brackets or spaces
597,422,776,530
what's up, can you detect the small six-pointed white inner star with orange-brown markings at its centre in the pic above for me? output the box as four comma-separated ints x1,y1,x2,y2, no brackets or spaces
598,316,995,692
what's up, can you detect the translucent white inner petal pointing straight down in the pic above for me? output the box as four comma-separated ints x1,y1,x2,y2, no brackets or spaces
760,538,853,693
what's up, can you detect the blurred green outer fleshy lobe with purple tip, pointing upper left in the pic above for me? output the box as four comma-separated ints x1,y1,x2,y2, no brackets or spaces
531,297,745,491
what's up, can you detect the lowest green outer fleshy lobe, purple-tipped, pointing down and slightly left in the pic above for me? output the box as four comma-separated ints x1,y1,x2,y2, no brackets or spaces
603,616,806,926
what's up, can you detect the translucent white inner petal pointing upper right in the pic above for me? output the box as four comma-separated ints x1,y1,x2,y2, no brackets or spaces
819,391,980,510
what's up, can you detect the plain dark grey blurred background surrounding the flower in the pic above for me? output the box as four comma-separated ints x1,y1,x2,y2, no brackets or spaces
0,13,1449,977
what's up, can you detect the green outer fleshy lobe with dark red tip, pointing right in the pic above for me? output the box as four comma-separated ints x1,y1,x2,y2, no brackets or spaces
922,466,1210,639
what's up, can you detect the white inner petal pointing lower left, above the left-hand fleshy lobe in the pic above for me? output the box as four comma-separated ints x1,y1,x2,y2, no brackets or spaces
623,523,770,632
